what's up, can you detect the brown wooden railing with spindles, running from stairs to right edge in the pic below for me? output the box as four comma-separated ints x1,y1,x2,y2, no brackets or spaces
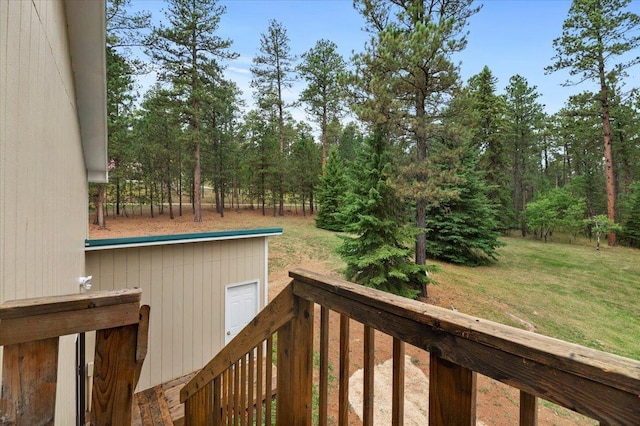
181,270,640,425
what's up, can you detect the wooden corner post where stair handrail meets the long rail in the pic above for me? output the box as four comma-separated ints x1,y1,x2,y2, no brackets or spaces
276,297,313,426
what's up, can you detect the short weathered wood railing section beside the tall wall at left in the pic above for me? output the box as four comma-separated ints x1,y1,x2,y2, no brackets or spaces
0,289,149,425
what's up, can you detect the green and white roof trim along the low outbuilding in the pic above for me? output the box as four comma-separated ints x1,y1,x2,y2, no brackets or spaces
84,228,282,250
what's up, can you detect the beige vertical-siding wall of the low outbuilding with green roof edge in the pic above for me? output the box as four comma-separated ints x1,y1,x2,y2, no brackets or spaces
86,237,267,389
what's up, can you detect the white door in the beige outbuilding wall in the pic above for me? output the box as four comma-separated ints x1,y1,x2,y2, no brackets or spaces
224,281,259,345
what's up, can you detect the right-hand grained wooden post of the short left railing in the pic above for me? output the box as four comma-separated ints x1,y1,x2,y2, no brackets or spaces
91,325,138,426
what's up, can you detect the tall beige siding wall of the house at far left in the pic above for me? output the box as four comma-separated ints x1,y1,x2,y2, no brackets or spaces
0,0,87,424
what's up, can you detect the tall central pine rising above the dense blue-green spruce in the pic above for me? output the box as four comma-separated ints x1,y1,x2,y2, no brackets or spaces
355,0,479,296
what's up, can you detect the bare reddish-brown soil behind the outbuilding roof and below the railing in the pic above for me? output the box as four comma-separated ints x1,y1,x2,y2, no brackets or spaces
89,206,596,426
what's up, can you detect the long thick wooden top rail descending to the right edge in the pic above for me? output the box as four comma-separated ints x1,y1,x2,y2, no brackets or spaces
289,270,640,424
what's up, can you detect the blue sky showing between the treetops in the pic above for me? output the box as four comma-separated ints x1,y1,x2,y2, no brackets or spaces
133,0,640,119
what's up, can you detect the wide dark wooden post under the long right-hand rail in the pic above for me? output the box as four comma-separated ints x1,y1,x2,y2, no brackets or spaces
429,353,476,426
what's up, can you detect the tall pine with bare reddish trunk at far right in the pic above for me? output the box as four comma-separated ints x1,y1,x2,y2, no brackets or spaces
546,0,640,246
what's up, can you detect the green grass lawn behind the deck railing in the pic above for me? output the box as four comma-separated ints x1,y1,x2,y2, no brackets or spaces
270,218,640,360
